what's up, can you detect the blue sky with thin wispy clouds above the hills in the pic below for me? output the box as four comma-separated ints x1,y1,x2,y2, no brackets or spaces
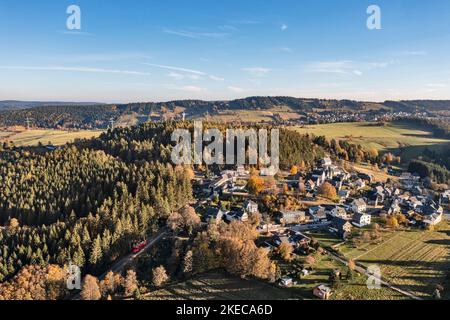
0,0,450,102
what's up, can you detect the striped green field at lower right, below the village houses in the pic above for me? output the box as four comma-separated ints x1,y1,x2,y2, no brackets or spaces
341,222,450,298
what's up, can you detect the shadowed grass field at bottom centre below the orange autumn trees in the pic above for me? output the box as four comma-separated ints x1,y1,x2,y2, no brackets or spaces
143,272,301,300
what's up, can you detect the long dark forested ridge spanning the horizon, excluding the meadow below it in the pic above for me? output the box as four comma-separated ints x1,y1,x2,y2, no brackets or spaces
0,97,450,129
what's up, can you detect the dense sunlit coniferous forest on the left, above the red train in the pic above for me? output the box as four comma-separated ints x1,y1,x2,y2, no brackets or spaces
0,122,192,281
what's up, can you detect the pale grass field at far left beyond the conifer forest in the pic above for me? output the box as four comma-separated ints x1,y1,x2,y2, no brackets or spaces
0,129,102,147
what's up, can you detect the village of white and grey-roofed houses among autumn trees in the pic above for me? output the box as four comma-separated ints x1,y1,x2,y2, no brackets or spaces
194,157,450,299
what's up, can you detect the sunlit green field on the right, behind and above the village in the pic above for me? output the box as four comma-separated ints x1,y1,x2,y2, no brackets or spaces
295,122,450,159
